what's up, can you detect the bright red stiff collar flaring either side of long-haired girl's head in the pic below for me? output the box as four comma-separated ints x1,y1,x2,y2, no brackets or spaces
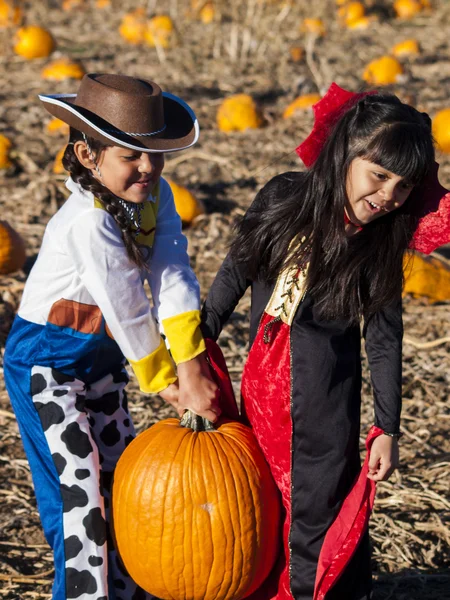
296,83,450,254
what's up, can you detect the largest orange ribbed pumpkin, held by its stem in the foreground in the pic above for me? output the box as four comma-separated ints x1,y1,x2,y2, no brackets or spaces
112,412,280,600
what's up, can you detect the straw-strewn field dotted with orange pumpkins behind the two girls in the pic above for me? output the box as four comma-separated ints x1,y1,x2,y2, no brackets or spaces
0,0,450,600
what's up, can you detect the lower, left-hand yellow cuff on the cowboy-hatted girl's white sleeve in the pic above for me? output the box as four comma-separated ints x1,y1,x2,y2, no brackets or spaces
128,339,177,394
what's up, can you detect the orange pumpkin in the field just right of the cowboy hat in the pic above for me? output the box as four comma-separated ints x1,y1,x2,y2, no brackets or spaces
217,94,264,132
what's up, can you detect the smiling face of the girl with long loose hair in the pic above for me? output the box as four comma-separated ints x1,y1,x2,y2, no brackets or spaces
345,157,414,226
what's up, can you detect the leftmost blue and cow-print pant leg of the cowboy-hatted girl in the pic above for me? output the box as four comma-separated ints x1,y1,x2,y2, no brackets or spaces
7,365,114,600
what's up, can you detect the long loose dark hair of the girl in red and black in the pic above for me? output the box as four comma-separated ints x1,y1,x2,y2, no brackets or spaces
231,94,434,322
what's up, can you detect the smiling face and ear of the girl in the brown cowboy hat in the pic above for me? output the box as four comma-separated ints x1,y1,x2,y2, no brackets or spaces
74,142,164,204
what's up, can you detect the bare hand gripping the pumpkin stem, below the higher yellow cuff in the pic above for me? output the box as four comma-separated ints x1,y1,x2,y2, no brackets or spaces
177,353,221,423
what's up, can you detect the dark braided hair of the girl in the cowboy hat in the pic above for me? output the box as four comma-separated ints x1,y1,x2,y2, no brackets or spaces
62,127,146,267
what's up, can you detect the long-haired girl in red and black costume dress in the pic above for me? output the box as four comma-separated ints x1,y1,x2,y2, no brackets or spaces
203,84,450,600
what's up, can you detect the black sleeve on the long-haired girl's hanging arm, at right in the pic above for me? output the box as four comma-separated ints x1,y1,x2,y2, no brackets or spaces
363,299,403,433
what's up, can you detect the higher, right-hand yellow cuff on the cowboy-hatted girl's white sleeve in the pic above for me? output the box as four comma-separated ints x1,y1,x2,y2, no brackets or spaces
162,310,206,365
